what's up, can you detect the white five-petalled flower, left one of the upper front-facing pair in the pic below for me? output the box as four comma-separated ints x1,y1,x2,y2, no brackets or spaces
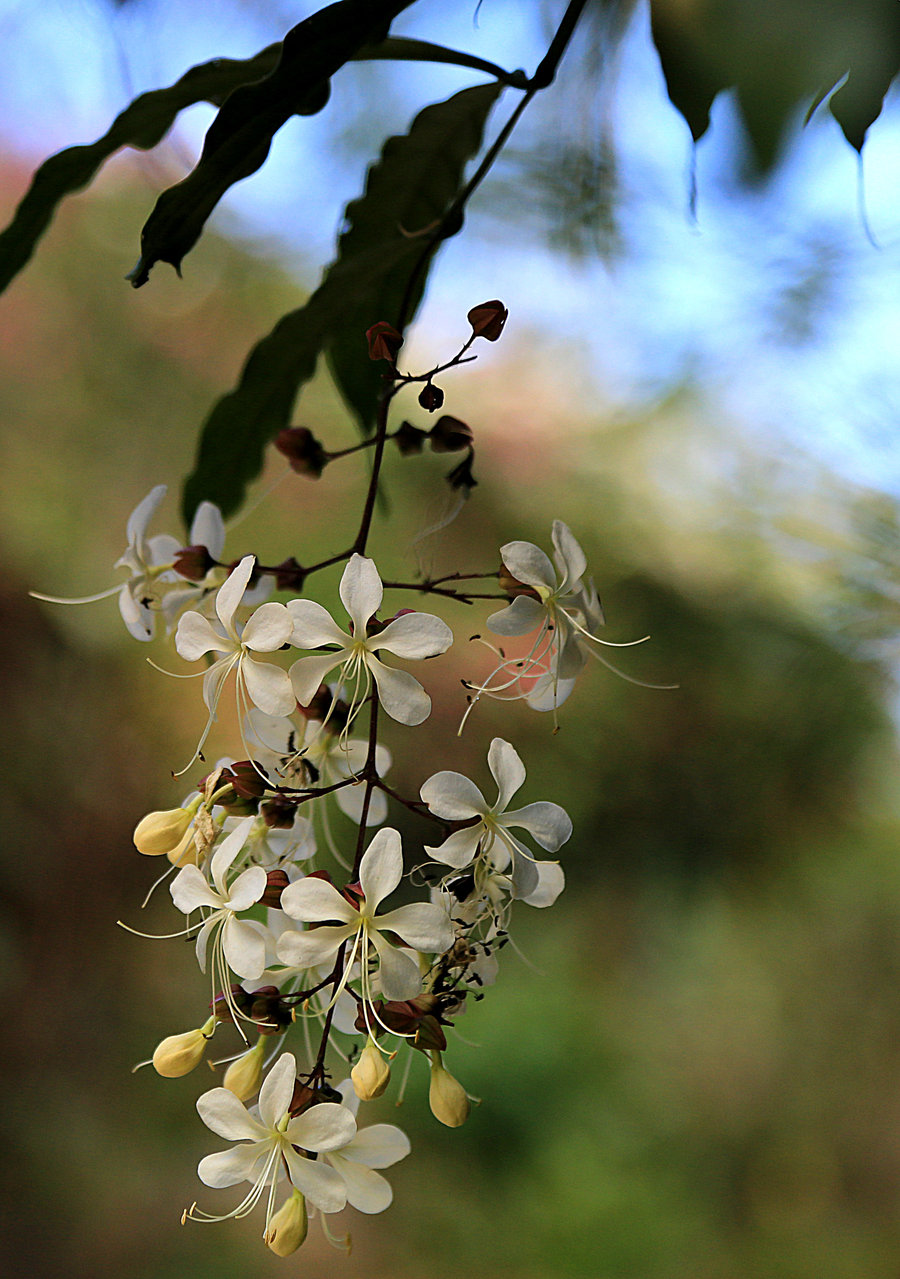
175,555,294,762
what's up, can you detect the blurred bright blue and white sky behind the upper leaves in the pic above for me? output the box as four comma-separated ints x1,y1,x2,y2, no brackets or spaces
0,0,900,492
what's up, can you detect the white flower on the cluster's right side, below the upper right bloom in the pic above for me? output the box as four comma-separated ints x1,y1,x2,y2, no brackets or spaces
421,737,571,906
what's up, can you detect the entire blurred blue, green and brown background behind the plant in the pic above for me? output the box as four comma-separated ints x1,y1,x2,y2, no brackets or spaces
0,0,900,1279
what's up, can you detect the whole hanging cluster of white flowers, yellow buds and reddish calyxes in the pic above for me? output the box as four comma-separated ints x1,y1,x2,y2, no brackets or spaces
33,302,659,1256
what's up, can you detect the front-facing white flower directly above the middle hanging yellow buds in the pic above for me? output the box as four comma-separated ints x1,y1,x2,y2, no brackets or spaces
277,826,454,1004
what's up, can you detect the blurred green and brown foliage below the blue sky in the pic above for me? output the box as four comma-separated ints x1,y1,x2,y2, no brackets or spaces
0,162,900,1279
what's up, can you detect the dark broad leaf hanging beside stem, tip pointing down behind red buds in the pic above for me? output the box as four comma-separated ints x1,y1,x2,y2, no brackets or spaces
327,83,501,434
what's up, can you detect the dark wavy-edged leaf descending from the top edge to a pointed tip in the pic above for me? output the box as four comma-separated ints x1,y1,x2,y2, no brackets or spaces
129,0,414,288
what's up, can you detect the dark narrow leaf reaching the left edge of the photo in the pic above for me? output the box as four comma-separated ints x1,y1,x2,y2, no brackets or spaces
0,45,281,292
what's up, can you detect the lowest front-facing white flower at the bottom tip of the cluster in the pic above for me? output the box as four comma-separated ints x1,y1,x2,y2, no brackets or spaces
185,1053,357,1234
